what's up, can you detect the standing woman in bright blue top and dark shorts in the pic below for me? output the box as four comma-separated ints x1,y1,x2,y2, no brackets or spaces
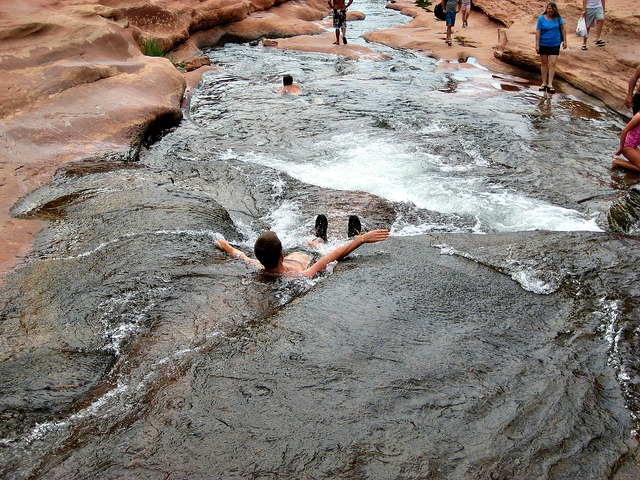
536,2,567,93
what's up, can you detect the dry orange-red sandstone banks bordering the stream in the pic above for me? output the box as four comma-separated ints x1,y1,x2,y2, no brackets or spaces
0,0,640,275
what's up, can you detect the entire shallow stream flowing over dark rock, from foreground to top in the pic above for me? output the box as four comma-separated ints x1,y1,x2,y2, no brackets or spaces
0,1,640,478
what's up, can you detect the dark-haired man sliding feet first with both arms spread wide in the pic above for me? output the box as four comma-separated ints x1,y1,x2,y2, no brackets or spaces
213,214,389,278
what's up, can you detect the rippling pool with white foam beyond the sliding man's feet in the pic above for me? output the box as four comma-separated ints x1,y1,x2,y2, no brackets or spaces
181,5,620,238
